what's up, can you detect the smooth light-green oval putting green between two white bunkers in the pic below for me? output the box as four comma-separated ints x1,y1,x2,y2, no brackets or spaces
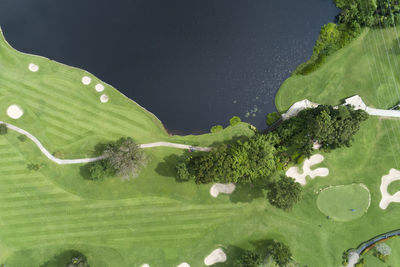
317,184,370,222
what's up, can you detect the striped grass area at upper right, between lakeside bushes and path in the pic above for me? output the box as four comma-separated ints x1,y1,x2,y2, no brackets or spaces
275,27,400,112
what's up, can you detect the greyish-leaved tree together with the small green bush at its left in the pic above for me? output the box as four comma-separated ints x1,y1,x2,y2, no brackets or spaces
89,137,145,180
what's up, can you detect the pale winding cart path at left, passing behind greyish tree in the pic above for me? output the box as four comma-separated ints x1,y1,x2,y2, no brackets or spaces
0,121,211,164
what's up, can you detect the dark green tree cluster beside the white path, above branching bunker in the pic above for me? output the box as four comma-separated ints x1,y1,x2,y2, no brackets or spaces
277,105,368,156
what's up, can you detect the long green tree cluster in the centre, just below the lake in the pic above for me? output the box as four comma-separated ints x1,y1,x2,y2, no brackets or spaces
188,133,278,183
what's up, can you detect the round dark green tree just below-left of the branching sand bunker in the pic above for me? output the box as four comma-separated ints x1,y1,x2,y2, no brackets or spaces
267,175,302,211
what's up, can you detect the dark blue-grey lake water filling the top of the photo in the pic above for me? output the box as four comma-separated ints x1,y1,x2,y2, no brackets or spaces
0,0,338,133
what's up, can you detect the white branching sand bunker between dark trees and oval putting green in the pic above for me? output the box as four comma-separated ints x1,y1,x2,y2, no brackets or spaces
286,154,329,185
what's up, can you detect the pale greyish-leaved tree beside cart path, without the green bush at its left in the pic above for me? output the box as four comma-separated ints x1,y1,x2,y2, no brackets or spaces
103,137,145,178
